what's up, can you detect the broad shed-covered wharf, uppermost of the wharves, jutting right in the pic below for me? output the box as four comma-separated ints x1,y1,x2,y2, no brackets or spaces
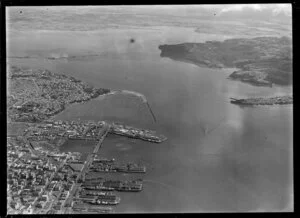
110,123,167,143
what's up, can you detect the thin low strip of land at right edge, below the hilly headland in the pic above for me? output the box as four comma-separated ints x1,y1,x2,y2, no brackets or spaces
230,96,293,105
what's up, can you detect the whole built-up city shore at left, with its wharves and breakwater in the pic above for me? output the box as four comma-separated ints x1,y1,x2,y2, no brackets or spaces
7,67,167,214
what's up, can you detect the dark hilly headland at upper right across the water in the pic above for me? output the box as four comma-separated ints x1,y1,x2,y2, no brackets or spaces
159,36,292,86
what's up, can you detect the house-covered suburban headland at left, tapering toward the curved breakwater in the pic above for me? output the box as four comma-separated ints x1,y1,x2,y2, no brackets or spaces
7,66,110,122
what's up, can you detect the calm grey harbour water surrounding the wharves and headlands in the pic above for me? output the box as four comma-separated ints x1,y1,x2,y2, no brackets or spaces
8,7,293,212
